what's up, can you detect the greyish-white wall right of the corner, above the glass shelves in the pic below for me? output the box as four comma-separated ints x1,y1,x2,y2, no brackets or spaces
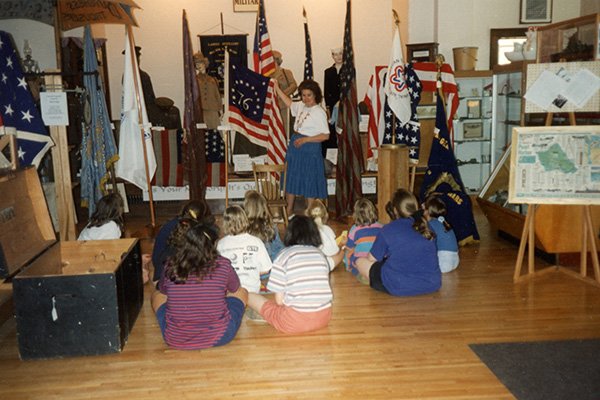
408,0,580,69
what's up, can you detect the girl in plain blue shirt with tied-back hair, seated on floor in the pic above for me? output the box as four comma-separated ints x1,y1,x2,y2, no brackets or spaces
356,189,442,296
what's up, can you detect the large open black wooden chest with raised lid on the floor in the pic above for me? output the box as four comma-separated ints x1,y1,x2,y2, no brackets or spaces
0,168,144,359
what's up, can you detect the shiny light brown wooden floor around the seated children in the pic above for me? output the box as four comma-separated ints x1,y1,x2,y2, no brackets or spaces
0,202,600,400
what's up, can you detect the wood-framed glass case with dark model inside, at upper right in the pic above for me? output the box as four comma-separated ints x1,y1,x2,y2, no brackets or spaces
537,13,600,63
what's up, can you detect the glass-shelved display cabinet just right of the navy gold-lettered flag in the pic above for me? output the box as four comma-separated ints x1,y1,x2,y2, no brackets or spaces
454,71,493,193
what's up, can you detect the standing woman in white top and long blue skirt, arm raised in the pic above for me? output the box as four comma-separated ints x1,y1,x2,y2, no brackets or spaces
275,80,329,216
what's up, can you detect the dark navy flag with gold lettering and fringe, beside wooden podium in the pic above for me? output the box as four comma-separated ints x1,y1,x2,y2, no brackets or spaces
421,96,479,245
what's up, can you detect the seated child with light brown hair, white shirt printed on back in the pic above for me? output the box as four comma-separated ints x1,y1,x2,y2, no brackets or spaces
217,206,271,293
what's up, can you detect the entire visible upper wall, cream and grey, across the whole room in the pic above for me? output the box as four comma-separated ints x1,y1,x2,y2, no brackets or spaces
0,0,599,119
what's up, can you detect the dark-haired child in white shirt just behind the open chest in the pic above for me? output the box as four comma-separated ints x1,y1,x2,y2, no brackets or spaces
77,193,124,240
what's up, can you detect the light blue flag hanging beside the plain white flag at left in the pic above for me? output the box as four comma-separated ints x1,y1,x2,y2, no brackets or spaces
81,25,119,216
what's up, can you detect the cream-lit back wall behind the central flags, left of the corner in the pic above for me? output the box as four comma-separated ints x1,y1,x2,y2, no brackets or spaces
105,0,392,118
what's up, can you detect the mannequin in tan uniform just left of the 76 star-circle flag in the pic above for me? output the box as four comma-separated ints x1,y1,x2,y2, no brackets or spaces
194,53,223,130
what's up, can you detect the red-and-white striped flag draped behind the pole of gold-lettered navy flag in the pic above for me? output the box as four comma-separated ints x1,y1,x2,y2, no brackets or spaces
413,62,459,137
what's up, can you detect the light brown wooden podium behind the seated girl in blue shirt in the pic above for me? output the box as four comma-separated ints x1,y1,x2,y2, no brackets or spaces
377,144,409,223
